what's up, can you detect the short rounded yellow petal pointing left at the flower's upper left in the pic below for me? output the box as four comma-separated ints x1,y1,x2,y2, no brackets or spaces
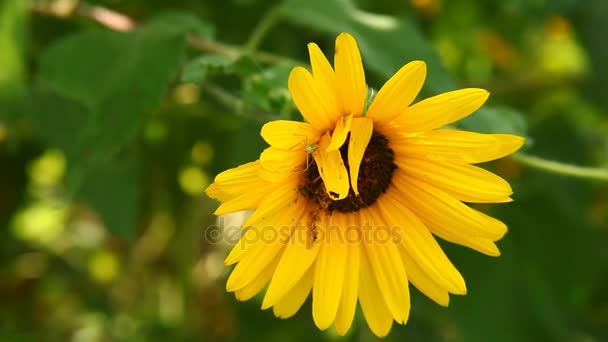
260,120,319,151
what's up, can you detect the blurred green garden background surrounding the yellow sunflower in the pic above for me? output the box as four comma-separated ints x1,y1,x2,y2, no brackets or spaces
0,0,608,342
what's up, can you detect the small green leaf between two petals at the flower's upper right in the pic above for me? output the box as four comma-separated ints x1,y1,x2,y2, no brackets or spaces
457,107,528,137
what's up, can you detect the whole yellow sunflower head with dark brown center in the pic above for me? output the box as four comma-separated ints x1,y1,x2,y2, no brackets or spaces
206,33,524,336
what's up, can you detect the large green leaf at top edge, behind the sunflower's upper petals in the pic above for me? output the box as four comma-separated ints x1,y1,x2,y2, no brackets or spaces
284,0,454,93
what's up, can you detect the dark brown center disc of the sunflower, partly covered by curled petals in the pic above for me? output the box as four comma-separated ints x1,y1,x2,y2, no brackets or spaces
300,131,397,213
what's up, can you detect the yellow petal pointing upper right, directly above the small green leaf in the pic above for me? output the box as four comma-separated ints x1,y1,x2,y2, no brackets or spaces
393,88,490,132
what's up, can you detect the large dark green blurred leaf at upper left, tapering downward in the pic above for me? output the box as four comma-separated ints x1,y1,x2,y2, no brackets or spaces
36,18,185,170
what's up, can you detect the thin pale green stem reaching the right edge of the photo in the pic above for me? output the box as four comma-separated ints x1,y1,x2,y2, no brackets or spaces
512,153,608,181
